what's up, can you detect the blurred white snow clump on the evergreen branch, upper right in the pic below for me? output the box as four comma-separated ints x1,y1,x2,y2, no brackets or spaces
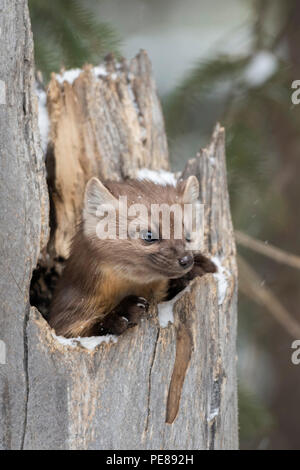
243,51,278,87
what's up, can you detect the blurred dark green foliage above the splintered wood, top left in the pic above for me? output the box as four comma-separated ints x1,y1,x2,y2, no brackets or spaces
29,0,119,79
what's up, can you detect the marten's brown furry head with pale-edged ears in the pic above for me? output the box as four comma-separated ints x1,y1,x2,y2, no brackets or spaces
83,176,199,283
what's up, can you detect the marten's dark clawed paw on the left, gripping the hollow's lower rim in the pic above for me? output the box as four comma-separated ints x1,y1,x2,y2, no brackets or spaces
99,295,149,335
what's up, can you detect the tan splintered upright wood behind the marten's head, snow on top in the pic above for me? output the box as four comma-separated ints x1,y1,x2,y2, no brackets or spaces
48,52,169,258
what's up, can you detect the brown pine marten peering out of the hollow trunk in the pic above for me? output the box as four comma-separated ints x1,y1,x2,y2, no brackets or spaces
48,176,216,337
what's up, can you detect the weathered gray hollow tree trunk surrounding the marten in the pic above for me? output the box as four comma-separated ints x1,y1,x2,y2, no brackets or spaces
0,0,238,450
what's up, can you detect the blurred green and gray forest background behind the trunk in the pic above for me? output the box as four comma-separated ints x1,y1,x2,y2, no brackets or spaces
29,0,300,449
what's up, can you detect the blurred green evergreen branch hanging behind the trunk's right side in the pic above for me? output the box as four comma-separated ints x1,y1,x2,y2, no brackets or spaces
164,51,294,236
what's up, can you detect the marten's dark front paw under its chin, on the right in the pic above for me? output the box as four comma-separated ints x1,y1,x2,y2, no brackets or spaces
167,253,217,300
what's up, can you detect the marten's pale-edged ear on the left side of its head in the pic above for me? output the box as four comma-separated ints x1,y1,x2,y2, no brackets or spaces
84,176,118,216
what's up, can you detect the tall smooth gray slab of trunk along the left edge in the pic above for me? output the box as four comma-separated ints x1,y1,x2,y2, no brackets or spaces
0,0,48,449
